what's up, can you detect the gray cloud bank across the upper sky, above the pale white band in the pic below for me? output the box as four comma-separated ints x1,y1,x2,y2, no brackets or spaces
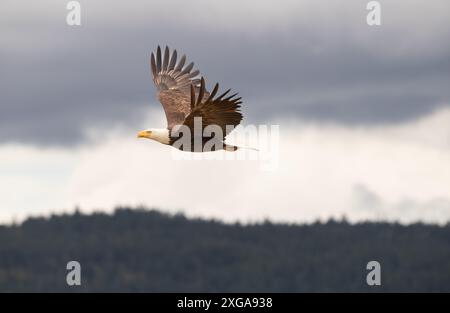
0,1,450,144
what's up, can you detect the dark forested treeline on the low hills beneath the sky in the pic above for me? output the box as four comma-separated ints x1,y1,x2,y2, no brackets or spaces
0,209,450,292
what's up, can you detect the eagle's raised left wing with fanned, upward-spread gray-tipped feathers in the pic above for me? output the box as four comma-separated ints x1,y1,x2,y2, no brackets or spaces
150,46,204,129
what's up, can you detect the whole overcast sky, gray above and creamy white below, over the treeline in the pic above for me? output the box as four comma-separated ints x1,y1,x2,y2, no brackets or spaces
0,0,450,222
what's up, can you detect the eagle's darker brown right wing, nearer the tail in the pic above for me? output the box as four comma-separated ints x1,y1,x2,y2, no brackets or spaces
183,77,242,138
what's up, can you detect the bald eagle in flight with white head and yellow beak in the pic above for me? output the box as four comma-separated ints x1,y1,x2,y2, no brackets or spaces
138,46,242,152
